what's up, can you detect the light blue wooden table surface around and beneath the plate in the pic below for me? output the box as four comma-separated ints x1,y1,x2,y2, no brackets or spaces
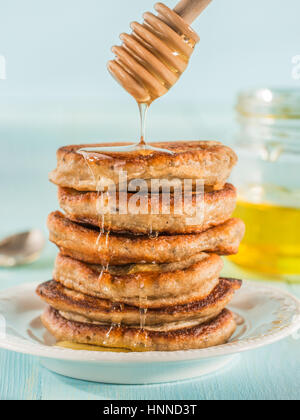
0,120,300,400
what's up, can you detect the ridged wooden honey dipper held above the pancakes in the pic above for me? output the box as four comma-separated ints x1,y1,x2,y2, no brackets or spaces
108,0,211,105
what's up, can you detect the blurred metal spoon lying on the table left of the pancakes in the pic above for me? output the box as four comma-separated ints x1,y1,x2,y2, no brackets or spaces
0,229,45,267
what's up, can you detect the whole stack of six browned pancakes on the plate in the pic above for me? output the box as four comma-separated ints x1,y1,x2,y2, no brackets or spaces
37,142,245,351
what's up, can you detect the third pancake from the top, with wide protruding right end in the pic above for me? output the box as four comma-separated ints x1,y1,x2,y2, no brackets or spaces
48,212,245,265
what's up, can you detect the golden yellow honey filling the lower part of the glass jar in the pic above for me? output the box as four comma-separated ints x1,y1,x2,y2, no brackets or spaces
230,201,300,276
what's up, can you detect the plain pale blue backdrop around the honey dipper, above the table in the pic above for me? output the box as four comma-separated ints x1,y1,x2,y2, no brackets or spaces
0,0,300,141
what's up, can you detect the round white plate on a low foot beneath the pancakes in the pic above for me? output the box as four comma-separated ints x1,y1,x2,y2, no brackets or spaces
0,282,300,384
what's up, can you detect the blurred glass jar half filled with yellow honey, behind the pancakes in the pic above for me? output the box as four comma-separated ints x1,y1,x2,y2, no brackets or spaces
230,89,300,282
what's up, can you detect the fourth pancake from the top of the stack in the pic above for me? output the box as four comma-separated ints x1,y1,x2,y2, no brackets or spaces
53,254,223,308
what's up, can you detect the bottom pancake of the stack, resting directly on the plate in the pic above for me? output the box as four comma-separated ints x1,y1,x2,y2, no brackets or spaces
42,307,236,352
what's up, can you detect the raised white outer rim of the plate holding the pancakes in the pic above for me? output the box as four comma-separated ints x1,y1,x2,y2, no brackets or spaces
0,280,300,363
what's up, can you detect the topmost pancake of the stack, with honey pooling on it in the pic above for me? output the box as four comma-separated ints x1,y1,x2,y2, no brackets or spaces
49,141,237,191
